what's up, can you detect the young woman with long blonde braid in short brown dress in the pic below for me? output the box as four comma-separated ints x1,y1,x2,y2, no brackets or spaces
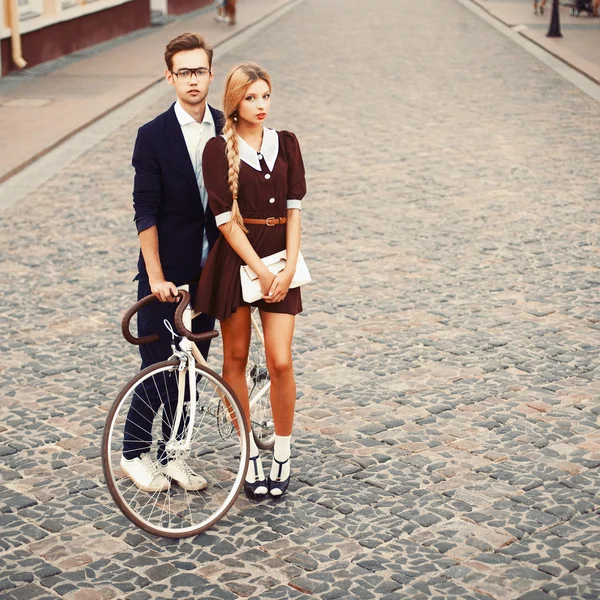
196,63,306,498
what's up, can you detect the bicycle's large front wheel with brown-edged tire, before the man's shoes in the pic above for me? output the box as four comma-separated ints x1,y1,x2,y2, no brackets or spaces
102,360,249,538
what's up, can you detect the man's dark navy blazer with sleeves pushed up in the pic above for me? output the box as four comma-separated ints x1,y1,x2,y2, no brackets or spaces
132,104,225,285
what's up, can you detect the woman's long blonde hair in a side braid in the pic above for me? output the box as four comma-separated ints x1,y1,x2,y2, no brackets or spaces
223,62,271,233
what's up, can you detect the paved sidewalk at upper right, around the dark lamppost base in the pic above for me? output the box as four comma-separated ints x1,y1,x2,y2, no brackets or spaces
471,0,600,84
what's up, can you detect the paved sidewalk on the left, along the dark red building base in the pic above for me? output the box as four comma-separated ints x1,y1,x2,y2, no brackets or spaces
0,0,290,183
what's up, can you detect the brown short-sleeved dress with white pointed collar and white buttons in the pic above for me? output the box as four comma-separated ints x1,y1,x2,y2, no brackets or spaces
195,129,306,321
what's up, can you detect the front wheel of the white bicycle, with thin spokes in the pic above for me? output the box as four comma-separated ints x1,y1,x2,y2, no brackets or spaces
102,360,248,538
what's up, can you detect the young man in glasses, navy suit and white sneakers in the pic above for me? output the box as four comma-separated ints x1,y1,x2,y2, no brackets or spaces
121,33,224,492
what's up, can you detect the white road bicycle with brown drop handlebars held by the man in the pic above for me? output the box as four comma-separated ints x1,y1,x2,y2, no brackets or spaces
102,288,274,538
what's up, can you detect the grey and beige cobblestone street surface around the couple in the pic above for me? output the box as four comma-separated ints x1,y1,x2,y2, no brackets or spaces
0,0,600,600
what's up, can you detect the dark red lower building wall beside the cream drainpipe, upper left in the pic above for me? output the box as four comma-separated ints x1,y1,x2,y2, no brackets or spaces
0,0,151,75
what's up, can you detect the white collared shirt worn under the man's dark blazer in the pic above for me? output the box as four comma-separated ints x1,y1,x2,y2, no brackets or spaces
175,100,217,266
